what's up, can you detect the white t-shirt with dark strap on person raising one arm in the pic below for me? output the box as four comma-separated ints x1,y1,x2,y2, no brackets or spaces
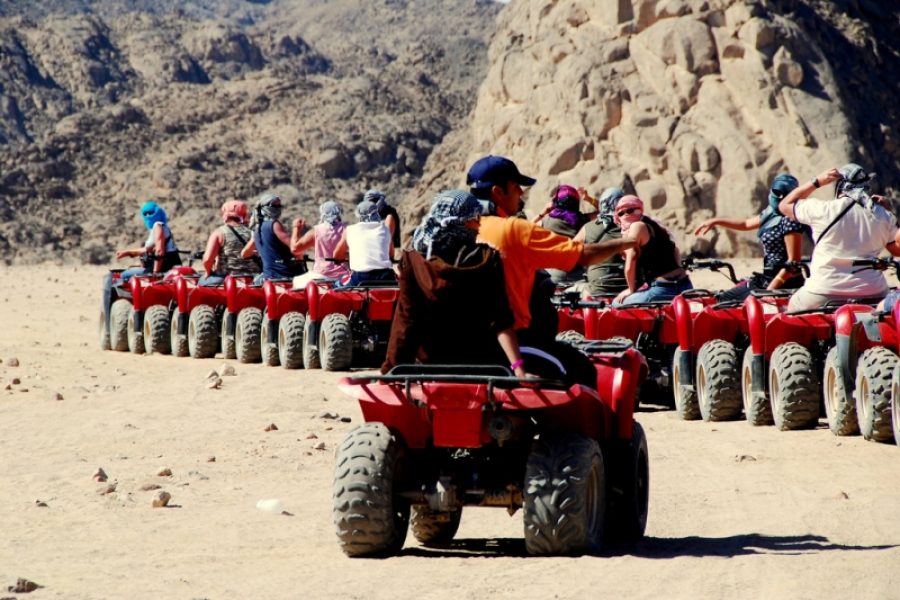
794,197,897,298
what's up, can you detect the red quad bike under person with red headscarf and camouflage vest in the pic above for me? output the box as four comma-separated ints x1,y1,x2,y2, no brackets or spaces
169,275,253,358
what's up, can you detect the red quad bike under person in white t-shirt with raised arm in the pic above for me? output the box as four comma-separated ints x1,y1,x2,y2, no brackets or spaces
741,278,879,431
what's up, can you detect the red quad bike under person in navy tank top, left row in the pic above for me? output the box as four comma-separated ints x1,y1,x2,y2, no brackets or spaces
222,276,292,366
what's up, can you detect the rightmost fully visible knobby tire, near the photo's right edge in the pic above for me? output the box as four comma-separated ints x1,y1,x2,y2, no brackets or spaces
856,346,898,442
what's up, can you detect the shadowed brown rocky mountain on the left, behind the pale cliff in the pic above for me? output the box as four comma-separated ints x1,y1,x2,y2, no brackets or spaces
0,0,502,262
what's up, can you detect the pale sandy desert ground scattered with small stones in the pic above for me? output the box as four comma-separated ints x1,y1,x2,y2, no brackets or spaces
0,266,900,600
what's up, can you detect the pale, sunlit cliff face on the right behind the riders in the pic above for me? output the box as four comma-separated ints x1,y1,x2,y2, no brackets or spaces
408,0,900,255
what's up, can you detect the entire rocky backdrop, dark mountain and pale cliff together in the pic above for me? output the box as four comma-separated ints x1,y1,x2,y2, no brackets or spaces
0,0,900,263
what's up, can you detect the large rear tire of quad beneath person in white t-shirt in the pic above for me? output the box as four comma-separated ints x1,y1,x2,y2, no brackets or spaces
769,342,821,431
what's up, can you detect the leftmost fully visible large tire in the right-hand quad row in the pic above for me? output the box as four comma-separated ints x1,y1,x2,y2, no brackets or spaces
695,340,743,421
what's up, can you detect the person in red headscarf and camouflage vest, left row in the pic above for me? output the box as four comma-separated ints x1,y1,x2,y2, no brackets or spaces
200,200,259,286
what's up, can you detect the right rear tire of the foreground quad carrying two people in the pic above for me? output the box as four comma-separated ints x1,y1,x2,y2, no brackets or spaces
523,433,606,555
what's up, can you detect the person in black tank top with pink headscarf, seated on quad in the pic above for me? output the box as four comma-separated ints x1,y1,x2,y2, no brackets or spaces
613,196,694,306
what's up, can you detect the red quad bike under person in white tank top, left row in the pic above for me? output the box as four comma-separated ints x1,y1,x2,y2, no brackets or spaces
304,281,400,371
